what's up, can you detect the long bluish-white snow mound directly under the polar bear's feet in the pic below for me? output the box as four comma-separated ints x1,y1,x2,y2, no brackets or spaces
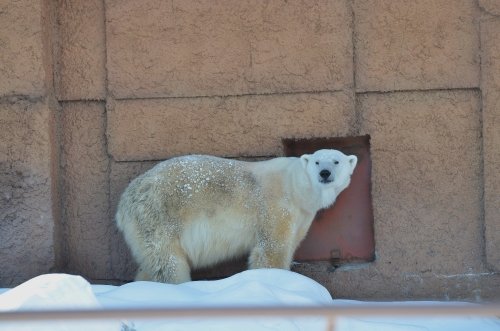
94,269,332,331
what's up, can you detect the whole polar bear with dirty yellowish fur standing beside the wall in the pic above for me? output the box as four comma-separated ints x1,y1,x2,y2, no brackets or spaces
116,149,357,284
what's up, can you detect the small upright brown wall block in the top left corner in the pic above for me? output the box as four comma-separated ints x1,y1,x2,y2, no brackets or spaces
0,0,46,97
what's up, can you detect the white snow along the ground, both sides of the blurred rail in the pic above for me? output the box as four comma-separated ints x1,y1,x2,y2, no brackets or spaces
0,269,500,331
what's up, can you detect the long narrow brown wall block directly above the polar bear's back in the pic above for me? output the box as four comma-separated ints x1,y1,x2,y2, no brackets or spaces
108,92,355,161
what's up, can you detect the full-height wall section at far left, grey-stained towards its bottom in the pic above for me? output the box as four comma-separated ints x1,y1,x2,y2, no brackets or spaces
0,0,60,286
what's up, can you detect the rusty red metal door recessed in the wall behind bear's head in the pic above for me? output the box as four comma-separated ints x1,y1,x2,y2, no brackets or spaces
283,136,375,264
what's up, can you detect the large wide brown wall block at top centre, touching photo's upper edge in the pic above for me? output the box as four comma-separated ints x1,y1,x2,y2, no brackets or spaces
106,0,353,99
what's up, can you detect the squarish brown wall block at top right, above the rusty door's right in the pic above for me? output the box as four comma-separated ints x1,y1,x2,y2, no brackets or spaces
354,0,480,91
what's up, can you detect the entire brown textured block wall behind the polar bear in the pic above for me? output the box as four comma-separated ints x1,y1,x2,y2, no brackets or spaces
0,0,500,300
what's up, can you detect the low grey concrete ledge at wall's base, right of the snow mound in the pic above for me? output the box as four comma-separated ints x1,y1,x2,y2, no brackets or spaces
293,262,500,302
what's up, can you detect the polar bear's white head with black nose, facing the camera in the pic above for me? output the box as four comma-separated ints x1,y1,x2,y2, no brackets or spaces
300,149,358,208
